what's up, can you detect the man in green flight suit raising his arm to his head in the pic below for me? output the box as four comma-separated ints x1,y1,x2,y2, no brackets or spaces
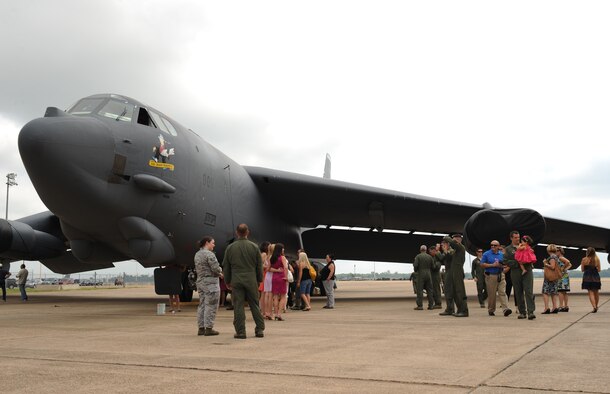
441,233,468,317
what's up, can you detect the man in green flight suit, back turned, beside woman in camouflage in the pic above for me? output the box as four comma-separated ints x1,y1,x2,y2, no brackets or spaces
222,223,265,339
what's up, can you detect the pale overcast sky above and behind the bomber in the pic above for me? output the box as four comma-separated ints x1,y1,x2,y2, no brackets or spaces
0,0,610,272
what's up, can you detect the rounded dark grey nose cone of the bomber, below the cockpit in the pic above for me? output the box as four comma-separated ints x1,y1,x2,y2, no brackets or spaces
18,111,114,210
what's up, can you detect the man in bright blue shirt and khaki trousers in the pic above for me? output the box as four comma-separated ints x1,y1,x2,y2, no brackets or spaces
481,240,513,316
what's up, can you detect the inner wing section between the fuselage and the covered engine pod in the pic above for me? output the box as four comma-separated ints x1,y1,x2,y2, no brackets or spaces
245,167,483,233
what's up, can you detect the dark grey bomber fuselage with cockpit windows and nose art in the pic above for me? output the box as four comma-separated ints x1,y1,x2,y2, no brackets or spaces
13,95,298,270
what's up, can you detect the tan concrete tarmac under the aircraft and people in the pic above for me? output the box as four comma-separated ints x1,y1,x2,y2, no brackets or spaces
0,279,610,393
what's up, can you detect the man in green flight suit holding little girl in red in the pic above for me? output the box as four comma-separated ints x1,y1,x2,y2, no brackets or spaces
504,231,536,320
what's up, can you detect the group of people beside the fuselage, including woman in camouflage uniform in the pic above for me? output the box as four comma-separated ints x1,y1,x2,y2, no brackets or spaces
194,224,335,339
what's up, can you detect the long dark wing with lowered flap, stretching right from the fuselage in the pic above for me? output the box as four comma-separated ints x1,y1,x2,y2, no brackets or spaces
245,167,610,262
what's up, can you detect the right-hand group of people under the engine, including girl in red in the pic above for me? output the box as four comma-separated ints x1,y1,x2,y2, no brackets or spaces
413,231,601,320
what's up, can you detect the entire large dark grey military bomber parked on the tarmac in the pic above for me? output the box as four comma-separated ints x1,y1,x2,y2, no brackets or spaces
0,94,610,299
